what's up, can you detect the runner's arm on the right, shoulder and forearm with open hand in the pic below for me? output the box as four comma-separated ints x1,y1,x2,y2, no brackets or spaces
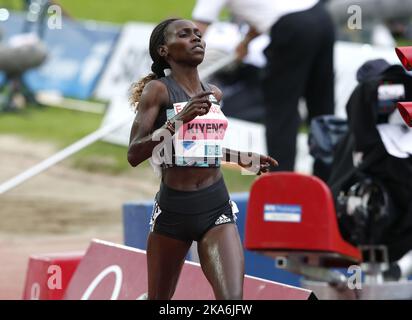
209,84,278,174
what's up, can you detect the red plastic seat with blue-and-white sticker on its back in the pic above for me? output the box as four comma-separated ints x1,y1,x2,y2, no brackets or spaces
245,172,361,267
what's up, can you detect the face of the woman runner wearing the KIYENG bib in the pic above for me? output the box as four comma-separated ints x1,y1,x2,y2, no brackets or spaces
159,20,206,66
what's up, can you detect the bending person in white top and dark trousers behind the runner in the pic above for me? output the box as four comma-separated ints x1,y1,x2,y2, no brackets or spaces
192,0,335,176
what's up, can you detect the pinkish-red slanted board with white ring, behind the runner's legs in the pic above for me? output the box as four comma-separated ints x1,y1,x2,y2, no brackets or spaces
64,240,313,300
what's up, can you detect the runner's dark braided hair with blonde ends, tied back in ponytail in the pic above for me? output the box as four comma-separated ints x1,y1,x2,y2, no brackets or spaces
129,19,180,111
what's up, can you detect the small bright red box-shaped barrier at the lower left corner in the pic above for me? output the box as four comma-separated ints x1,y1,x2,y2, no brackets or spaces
23,252,84,300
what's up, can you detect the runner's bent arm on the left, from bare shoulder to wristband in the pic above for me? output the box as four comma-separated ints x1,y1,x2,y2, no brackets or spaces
127,80,171,167
